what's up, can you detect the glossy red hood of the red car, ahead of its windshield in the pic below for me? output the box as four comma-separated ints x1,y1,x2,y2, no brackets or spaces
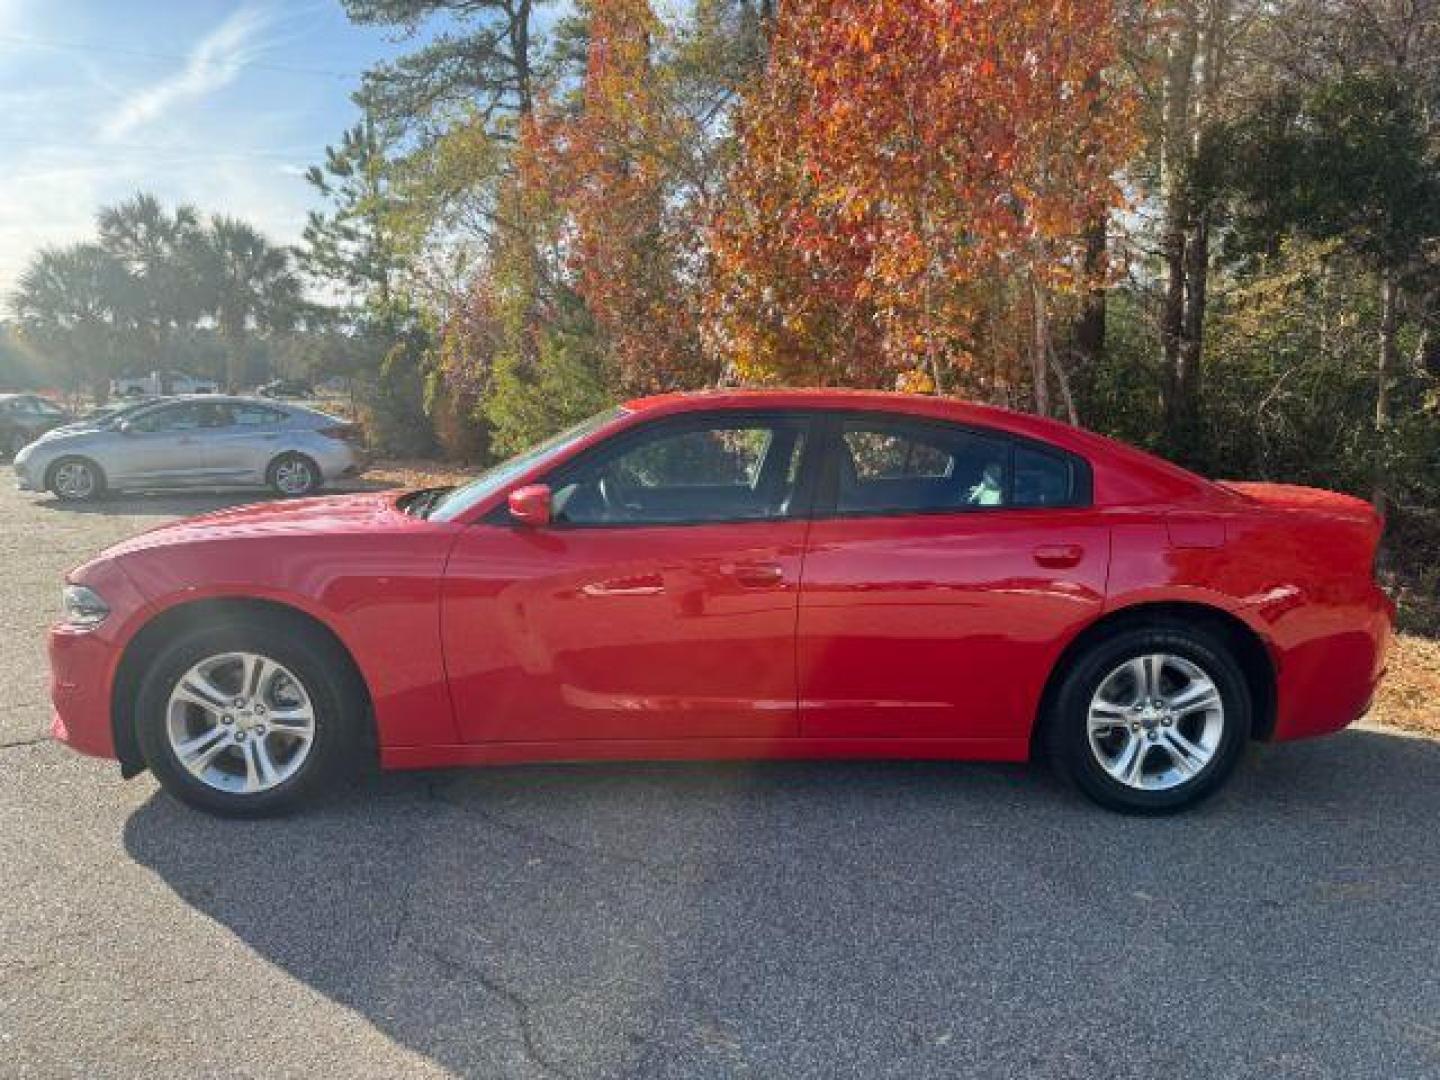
104,491,415,557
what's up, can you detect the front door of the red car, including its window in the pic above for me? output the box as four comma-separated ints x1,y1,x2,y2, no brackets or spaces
442,413,808,742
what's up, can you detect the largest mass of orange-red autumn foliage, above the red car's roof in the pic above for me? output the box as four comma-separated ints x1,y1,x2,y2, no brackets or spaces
708,0,1138,390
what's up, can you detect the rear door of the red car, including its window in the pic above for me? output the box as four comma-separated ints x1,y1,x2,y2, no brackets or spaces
796,415,1109,740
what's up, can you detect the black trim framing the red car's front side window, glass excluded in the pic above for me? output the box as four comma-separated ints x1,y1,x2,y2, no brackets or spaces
481,408,825,531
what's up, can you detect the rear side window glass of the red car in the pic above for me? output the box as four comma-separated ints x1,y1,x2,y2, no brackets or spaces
834,416,1089,514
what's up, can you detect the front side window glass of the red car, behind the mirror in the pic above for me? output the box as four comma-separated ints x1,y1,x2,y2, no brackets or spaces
553,418,806,526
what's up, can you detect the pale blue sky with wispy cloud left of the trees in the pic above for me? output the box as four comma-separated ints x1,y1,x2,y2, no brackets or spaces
0,0,408,305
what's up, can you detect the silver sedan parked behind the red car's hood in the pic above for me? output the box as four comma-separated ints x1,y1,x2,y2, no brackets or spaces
14,395,361,501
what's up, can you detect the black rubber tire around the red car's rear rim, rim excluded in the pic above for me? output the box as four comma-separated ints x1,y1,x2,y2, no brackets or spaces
1044,621,1254,814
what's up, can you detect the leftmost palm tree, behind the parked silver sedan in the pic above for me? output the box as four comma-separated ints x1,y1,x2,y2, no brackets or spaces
10,243,137,399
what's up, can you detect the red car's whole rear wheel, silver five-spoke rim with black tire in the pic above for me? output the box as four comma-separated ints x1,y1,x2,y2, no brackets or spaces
1047,624,1253,814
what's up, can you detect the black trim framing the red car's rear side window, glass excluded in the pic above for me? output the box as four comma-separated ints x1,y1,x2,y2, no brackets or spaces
811,409,1094,521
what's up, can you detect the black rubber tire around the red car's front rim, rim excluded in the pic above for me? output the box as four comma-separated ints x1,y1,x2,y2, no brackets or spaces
135,613,364,818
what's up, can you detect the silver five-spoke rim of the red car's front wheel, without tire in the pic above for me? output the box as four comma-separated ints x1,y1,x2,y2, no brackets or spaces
166,652,315,795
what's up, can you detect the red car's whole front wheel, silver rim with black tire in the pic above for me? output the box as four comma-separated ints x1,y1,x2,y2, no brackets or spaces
135,618,359,816
